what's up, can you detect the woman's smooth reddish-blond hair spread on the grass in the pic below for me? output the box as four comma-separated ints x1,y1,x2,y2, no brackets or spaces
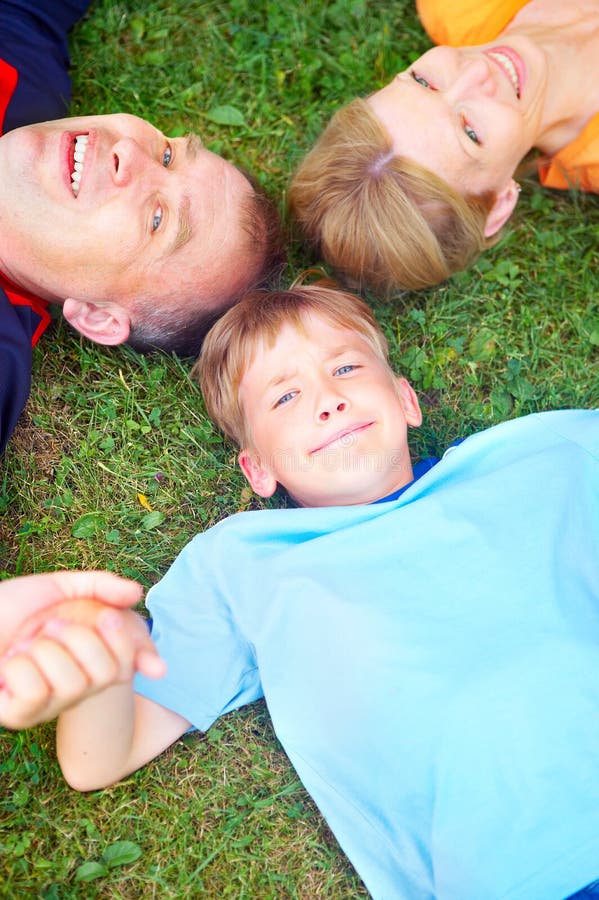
289,99,495,295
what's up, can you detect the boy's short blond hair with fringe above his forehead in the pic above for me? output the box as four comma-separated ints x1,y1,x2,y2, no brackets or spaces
197,283,389,448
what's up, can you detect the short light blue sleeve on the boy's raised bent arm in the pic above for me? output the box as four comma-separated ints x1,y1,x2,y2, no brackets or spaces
135,526,262,731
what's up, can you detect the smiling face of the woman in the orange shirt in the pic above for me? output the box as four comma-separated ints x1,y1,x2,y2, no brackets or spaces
368,37,545,194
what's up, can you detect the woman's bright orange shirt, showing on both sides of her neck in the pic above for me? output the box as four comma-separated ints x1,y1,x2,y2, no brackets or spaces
416,0,599,194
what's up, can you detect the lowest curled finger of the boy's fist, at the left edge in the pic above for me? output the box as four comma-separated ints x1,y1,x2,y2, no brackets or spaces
0,656,50,728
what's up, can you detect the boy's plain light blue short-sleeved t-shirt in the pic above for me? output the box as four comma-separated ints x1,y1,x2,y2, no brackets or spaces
136,411,599,900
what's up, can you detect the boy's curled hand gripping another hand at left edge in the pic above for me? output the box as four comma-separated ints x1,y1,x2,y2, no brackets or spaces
0,600,165,728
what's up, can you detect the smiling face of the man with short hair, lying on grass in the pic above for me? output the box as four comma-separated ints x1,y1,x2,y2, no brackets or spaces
0,115,257,307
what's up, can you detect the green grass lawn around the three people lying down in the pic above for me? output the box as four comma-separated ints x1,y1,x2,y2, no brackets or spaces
0,0,599,900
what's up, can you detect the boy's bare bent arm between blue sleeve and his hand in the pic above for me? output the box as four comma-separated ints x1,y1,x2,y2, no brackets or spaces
56,680,190,791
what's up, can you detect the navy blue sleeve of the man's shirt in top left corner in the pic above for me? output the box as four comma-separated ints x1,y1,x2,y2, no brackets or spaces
0,0,90,132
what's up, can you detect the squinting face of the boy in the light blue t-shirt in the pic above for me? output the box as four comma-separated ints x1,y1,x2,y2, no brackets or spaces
239,314,422,506
